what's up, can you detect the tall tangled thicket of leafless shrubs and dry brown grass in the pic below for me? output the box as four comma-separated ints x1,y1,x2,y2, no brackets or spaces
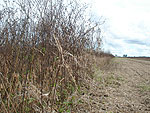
0,0,110,113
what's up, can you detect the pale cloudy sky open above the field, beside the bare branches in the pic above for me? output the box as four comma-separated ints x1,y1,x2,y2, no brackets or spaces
85,0,150,56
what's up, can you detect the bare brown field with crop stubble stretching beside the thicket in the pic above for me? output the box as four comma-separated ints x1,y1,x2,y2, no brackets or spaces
77,58,150,113
